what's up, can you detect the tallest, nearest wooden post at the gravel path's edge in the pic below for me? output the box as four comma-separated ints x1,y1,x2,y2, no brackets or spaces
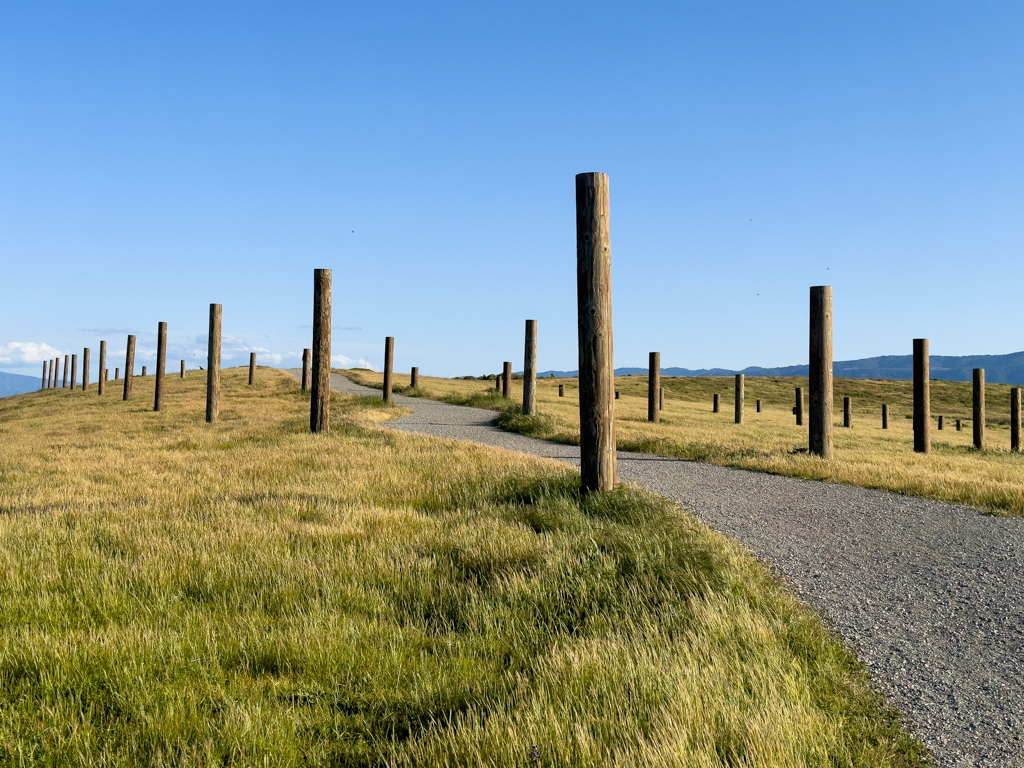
575,173,617,494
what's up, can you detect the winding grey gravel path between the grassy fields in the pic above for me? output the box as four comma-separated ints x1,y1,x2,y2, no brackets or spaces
299,374,1024,768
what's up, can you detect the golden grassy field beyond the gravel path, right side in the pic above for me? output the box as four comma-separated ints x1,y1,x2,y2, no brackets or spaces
349,371,1024,515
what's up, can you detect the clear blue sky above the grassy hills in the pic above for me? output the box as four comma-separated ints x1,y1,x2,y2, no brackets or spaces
0,0,1024,377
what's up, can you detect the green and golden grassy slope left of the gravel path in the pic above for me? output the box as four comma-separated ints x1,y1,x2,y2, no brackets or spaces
0,369,924,767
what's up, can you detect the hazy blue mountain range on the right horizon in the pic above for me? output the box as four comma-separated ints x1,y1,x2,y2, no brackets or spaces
538,352,1024,384
